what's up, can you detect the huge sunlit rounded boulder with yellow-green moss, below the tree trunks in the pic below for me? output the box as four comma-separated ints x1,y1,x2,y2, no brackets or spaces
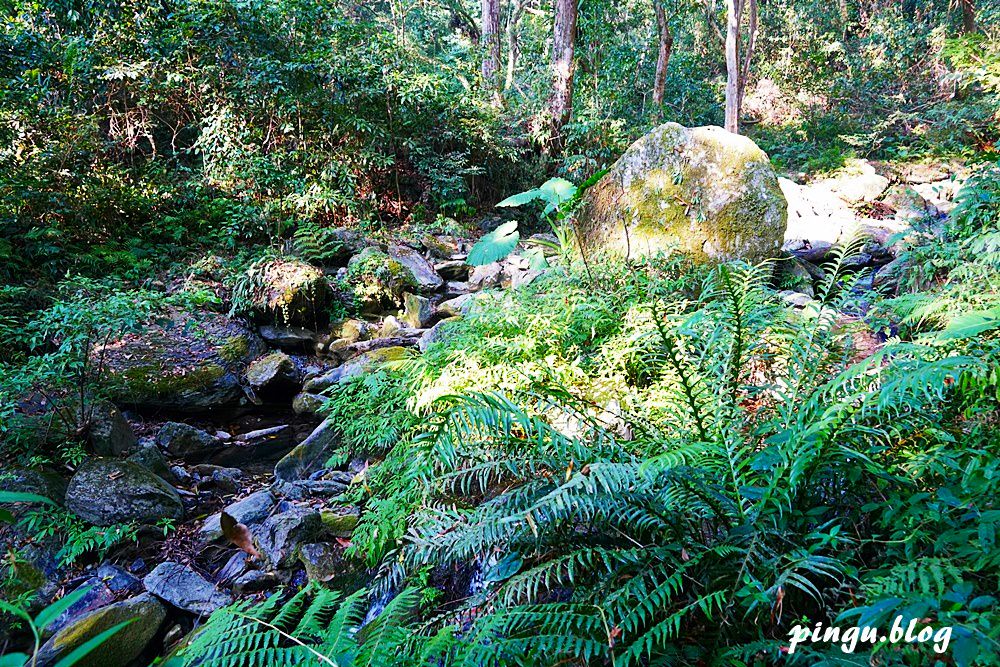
577,123,787,261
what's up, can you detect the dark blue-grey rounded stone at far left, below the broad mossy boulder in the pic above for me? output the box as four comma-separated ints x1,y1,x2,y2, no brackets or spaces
66,459,184,526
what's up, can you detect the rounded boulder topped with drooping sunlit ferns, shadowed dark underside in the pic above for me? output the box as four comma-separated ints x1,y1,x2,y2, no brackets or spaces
246,258,333,327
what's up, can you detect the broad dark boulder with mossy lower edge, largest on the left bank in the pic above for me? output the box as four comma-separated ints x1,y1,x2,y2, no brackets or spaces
93,312,265,413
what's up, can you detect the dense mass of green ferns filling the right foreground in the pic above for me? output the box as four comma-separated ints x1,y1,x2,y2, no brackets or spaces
164,162,1000,665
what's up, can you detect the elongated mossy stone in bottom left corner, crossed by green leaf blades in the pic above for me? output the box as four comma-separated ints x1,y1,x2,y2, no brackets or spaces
37,593,167,667
